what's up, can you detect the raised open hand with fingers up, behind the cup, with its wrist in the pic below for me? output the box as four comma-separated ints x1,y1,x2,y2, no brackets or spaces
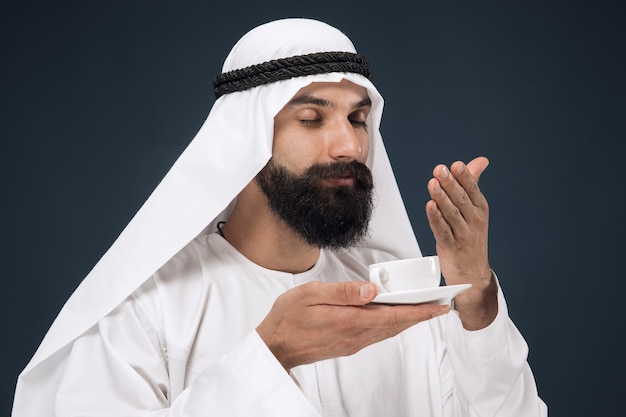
426,157,497,330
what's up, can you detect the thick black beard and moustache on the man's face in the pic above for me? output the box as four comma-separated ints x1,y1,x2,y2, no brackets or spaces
255,160,374,249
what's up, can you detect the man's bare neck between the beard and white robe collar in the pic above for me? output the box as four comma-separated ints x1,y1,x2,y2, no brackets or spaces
222,183,320,273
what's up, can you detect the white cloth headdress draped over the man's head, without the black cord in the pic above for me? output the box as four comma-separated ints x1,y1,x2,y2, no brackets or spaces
13,19,420,400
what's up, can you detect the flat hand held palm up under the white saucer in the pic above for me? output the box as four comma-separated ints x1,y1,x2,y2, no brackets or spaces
256,281,450,370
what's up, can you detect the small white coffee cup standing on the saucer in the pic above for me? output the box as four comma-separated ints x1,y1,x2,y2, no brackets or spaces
369,256,441,294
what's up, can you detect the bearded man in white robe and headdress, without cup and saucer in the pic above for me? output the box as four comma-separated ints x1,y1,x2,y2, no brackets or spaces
13,19,546,417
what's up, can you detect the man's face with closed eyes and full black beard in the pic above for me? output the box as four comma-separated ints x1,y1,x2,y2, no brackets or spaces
256,81,373,249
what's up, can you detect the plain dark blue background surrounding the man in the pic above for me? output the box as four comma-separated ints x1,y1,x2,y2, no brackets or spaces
0,0,626,416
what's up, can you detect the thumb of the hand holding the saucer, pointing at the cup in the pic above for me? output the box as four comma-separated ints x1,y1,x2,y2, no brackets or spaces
301,281,377,306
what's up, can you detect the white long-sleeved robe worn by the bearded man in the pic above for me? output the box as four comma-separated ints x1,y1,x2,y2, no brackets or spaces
51,234,547,417
